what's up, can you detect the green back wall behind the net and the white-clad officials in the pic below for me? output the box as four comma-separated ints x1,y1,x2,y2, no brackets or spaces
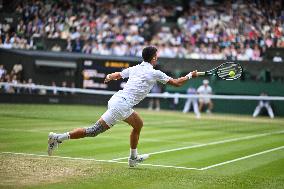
166,78,284,116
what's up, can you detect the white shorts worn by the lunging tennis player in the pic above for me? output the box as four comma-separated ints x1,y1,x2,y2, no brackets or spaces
102,95,134,127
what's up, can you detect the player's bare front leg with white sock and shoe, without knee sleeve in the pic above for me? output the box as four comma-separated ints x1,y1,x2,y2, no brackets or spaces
124,112,149,167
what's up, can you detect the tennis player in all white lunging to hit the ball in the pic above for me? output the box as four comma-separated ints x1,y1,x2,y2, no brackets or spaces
48,46,198,167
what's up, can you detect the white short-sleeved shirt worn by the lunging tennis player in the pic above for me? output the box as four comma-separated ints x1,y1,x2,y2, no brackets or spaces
114,62,171,107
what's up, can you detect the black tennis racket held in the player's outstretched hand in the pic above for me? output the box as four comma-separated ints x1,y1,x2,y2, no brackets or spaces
197,62,243,80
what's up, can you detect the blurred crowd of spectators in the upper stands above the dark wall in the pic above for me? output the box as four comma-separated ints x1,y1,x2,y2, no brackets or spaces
0,0,284,61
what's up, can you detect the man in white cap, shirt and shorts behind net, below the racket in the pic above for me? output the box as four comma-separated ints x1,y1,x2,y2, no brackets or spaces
197,79,213,113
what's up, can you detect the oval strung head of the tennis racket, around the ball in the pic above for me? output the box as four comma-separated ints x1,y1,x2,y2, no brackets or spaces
215,62,243,80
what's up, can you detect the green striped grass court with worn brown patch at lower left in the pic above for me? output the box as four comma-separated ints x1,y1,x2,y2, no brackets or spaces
0,104,284,189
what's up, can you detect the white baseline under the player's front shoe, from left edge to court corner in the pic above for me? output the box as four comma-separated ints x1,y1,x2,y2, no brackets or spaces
0,152,200,171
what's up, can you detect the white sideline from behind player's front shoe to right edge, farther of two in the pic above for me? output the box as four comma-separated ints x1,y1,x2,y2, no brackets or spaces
112,130,284,161
